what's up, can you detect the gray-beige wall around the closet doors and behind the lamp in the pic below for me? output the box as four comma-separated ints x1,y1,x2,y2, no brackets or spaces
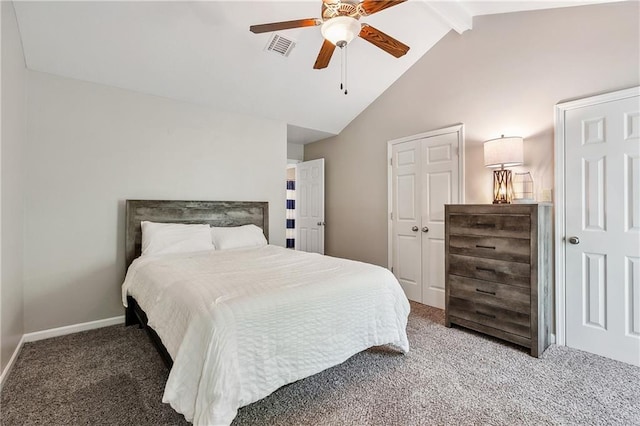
305,2,640,265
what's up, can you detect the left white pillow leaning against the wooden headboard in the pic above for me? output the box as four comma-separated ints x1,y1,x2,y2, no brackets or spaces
140,220,215,256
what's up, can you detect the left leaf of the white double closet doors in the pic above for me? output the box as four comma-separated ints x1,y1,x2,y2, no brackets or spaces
391,140,422,303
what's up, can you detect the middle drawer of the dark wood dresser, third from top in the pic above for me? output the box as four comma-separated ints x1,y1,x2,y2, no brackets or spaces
449,254,531,288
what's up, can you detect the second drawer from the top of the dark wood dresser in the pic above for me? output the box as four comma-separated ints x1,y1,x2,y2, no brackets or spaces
449,235,531,263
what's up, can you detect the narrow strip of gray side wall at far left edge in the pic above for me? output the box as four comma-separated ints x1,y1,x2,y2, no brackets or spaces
0,1,26,371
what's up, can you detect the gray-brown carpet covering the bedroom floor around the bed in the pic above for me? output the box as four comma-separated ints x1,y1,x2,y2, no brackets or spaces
0,304,640,426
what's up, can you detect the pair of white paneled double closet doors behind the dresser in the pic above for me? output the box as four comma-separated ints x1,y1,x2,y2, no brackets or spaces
389,125,463,308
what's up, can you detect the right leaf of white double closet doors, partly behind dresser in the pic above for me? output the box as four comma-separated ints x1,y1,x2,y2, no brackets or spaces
420,132,459,309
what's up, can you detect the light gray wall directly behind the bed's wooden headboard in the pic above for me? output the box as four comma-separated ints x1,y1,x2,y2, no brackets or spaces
24,71,287,332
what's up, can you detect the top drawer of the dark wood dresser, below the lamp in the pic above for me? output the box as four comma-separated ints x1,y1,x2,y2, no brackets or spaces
449,214,531,238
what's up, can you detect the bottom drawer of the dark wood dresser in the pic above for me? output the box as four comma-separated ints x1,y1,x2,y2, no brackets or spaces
448,297,531,338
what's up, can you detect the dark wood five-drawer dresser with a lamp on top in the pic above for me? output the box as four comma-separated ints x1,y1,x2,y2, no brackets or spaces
445,204,553,357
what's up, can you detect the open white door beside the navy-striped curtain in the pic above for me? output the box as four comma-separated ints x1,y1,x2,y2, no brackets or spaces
295,158,325,254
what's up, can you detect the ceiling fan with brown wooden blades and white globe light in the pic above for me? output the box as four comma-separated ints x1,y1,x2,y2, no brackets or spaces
249,0,409,69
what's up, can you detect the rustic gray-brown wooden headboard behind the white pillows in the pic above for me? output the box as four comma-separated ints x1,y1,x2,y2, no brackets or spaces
125,200,269,267
